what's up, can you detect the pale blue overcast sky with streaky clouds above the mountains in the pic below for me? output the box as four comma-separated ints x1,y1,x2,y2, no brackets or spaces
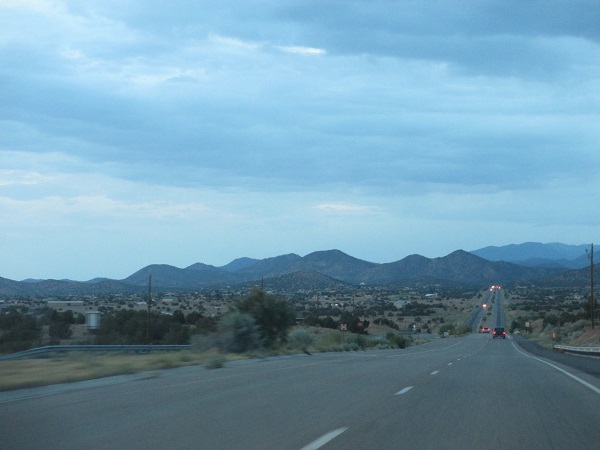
0,0,600,280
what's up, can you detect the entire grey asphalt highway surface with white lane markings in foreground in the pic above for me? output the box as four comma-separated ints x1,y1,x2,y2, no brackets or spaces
0,333,600,450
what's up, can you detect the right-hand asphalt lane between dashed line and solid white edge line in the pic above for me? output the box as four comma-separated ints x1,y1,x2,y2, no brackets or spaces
325,335,600,449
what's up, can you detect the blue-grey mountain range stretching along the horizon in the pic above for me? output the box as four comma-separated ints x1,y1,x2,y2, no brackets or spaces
0,243,589,296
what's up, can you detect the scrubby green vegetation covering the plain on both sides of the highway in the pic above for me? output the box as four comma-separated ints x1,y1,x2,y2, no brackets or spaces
9,288,600,390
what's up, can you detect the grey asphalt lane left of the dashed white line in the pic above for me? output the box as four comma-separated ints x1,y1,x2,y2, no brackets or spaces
0,340,482,449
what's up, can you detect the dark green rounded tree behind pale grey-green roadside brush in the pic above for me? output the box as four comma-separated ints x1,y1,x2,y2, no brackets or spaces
234,289,296,347
